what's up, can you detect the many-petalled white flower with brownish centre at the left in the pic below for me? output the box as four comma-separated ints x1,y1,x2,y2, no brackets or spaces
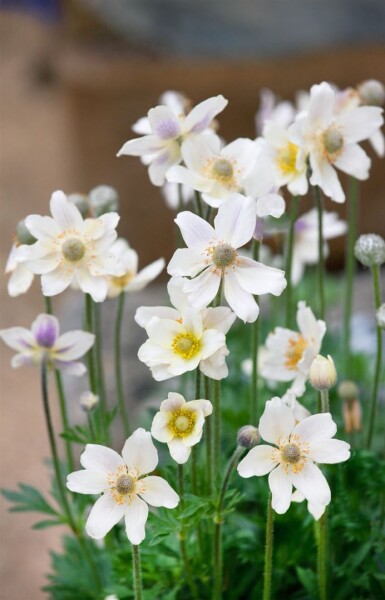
16,191,124,302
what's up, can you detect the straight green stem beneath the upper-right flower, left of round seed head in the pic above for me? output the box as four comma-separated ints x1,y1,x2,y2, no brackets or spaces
343,177,359,376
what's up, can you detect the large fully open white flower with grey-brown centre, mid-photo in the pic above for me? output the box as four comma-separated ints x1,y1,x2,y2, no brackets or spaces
167,194,286,322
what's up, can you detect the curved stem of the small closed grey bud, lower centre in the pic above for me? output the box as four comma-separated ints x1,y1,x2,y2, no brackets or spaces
213,446,244,600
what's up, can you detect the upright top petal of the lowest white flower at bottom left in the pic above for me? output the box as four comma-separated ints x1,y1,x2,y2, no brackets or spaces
122,427,158,475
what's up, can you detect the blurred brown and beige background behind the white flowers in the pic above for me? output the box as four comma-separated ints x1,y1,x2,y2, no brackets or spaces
0,0,385,600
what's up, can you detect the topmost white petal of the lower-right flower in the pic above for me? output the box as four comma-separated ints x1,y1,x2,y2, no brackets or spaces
258,397,294,444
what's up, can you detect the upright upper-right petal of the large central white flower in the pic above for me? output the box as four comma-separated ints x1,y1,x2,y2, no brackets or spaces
214,194,257,248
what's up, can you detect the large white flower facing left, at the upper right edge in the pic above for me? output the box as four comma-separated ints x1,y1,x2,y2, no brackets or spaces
289,82,383,203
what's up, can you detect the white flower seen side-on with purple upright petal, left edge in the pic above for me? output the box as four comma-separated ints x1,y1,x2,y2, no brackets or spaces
0,314,95,375
